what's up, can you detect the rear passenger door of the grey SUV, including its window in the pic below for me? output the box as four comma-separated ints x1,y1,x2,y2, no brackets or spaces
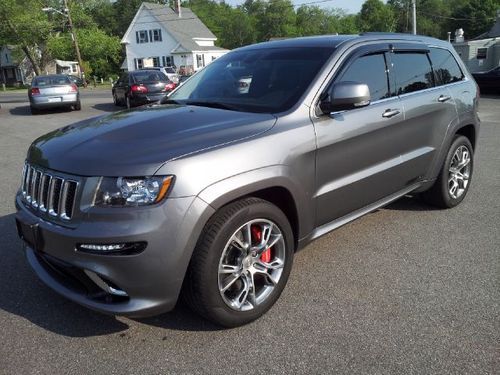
389,45,457,181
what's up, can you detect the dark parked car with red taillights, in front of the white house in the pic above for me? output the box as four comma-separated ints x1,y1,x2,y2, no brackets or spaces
112,69,176,108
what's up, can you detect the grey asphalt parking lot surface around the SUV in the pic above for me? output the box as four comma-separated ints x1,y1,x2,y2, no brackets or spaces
0,89,500,374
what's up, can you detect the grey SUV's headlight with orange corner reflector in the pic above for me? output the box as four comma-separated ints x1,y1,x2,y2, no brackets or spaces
94,176,174,207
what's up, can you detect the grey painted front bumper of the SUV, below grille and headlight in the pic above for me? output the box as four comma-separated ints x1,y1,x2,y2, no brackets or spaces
16,195,214,317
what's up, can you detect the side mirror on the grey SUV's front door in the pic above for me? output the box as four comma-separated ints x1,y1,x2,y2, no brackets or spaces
319,81,370,114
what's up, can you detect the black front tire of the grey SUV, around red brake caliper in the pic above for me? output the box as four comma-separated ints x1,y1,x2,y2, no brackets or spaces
182,198,294,327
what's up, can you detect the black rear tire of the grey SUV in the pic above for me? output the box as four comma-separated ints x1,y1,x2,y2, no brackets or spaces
422,135,474,208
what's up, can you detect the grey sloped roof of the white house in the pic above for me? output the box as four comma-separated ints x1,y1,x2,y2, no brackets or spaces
122,2,223,51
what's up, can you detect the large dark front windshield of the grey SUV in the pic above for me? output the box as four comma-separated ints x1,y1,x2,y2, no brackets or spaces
168,47,333,113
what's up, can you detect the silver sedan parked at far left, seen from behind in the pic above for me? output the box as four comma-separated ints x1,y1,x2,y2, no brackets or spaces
28,74,82,114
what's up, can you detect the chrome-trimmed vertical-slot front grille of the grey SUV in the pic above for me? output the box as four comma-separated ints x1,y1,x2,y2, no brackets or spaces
21,164,78,220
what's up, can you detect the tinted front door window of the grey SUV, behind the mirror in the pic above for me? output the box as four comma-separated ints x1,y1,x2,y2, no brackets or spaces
336,53,390,101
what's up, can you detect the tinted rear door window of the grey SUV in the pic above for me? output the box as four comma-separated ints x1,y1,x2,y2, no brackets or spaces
391,52,434,95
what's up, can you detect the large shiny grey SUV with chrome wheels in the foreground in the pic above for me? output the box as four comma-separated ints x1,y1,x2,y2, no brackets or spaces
16,34,479,327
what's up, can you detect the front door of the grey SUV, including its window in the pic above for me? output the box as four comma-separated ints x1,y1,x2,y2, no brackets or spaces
313,45,411,226
